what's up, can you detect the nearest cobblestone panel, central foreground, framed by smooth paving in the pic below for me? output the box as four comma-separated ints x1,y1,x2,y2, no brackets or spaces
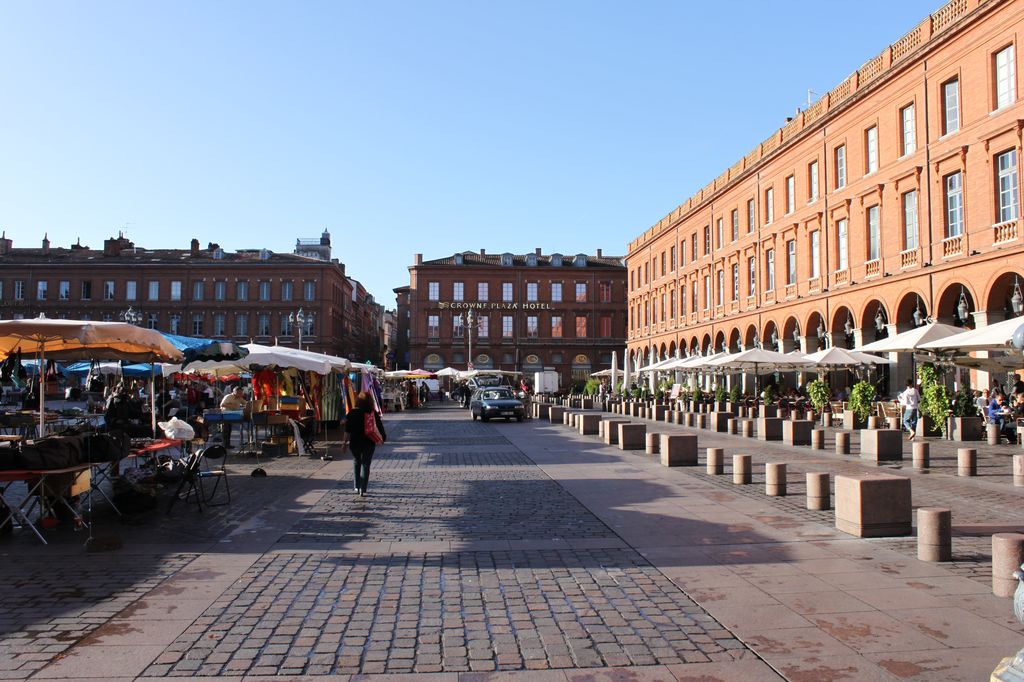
146,549,751,676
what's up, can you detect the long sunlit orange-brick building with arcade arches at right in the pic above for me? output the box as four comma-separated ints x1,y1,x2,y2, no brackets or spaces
627,0,1024,390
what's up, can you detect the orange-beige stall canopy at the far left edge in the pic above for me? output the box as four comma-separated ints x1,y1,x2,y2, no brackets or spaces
0,317,184,363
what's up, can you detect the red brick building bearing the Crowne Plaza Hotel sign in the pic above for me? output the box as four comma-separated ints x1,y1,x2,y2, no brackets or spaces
403,249,626,386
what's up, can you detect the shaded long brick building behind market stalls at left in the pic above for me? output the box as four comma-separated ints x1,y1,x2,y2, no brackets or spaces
0,232,382,361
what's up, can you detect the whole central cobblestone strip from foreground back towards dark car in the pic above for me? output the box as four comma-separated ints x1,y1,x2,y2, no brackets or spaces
146,413,752,676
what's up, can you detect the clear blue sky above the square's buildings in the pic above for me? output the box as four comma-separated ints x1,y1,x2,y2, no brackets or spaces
0,0,941,307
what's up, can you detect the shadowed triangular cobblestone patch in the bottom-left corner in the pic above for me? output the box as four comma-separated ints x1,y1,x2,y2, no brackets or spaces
0,554,196,679
